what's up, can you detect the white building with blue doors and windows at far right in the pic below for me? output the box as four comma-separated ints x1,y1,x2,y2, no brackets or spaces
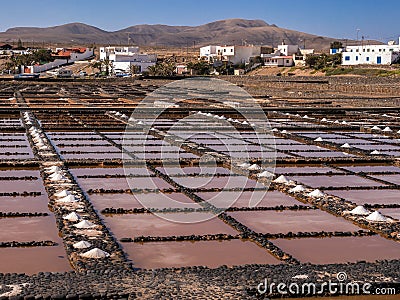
342,38,400,66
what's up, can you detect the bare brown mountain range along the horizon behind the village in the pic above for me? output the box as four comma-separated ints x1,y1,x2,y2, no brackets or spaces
0,19,344,50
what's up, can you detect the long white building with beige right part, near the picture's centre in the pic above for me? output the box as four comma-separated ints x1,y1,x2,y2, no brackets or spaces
200,45,261,65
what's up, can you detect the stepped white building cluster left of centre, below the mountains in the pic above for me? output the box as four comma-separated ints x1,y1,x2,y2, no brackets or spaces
100,46,157,73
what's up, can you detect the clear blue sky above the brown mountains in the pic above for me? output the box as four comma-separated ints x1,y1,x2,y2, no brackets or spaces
0,0,400,41
